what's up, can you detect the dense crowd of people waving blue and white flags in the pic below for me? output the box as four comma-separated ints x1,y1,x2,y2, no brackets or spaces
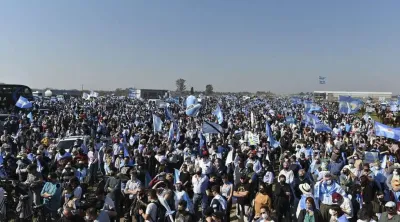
0,96,400,222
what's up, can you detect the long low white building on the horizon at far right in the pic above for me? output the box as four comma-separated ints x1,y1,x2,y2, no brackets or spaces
314,91,393,100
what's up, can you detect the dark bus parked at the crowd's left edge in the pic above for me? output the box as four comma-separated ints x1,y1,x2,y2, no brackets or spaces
0,84,34,108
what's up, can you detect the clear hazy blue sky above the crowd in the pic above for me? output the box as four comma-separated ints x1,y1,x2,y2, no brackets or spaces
0,0,400,93
